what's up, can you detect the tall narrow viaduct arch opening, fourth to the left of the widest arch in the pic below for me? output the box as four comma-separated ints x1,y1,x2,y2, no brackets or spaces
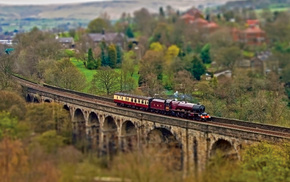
73,109,86,141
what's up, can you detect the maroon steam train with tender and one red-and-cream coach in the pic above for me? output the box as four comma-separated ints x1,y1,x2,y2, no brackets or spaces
114,93,211,121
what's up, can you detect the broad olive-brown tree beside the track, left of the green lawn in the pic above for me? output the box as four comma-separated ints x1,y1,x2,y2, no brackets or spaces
44,59,86,91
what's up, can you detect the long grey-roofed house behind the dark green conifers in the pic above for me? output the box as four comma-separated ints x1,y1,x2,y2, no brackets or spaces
88,32,127,48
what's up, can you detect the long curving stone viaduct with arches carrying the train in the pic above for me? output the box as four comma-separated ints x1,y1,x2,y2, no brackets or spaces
24,84,289,171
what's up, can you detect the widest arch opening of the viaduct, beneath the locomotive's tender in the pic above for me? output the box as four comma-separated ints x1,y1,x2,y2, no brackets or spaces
147,128,183,170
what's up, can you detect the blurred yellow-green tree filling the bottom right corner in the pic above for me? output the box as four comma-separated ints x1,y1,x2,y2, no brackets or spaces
239,142,290,182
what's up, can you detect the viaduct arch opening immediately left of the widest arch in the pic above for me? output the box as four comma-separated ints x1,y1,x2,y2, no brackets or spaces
121,120,138,151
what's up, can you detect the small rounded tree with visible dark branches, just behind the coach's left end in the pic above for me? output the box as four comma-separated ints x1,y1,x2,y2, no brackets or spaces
90,67,120,95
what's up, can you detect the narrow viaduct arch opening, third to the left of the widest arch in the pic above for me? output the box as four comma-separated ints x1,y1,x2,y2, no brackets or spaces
87,112,100,149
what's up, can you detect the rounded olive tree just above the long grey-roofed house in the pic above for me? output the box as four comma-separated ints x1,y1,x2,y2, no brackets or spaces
88,18,111,33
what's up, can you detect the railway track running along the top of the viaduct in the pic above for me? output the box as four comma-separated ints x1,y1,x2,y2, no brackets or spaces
14,76,290,140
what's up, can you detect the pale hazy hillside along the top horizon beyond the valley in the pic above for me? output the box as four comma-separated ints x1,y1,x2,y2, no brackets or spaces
0,0,228,20
